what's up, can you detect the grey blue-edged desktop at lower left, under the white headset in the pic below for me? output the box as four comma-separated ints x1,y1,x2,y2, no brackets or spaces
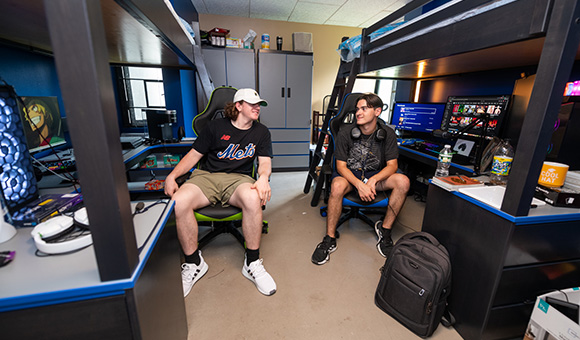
0,201,173,312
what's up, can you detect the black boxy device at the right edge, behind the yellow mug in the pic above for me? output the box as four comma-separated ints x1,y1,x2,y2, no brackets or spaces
546,97,580,170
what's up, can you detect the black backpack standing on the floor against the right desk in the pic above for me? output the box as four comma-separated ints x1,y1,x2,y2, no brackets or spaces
375,232,451,338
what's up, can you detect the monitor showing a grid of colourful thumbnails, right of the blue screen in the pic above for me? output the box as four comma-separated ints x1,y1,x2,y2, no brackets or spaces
441,95,510,137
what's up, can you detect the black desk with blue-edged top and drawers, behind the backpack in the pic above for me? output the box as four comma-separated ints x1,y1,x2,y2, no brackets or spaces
422,184,580,340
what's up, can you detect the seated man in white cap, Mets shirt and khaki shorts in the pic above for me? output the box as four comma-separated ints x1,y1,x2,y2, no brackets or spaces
165,89,276,296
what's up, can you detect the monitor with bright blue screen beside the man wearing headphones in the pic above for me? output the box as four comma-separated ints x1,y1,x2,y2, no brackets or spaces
391,102,445,133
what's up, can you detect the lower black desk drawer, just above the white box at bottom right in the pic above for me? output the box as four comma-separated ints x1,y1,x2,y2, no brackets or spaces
493,260,580,306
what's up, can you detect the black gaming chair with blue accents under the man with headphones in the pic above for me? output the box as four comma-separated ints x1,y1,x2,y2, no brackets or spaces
320,93,390,228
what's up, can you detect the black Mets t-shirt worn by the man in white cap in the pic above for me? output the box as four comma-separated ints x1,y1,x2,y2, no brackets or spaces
192,118,272,176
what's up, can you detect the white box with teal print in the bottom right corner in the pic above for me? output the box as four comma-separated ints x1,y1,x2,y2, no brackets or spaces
524,287,580,340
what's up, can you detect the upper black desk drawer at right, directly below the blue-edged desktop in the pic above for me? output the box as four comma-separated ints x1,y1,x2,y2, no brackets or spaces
504,221,580,267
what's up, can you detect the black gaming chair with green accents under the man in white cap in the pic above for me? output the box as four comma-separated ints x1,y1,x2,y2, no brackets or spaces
192,87,268,249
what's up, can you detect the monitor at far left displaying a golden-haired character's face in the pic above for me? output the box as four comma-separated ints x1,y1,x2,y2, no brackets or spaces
19,97,66,153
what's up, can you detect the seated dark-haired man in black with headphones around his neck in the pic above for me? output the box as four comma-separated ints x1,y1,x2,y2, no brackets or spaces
312,93,410,265
